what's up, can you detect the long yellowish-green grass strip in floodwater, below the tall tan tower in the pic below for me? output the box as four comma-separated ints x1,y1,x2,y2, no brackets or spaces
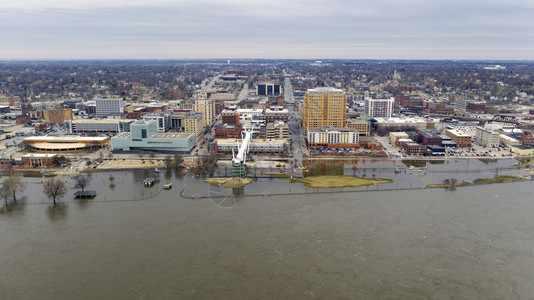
289,175,393,189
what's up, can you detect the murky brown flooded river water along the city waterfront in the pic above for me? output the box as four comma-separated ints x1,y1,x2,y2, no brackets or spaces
0,161,534,299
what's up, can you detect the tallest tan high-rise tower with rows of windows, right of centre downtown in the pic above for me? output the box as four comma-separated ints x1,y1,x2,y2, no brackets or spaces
301,87,347,129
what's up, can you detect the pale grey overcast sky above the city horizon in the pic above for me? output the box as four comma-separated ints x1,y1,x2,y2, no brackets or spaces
0,0,534,60
